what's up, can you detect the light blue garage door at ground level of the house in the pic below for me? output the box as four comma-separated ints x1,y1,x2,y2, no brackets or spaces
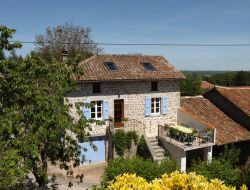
79,138,105,163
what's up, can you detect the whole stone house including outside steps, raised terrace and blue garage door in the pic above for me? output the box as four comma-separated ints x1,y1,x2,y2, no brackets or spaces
66,55,219,172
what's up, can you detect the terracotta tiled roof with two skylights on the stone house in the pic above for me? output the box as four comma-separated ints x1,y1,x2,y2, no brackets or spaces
77,55,185,81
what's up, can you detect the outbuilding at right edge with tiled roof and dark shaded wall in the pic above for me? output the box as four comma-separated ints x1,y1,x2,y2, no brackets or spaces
204,86,250,131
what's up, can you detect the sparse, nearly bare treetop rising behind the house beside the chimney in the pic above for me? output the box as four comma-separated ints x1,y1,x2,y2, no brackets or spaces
36,23,101,61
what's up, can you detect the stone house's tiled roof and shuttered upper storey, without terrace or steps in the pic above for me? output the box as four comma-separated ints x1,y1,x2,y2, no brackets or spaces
67,55,184,157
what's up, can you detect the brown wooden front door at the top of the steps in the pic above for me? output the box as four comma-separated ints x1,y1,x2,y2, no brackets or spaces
114,100,124,127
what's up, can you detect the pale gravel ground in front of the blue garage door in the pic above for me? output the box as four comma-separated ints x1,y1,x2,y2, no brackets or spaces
27,162,107,190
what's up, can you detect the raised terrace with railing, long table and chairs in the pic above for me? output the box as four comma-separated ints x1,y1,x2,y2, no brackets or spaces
158,124,216,151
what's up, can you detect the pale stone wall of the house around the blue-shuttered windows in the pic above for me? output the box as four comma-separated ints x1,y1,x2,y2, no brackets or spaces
66,80,180,136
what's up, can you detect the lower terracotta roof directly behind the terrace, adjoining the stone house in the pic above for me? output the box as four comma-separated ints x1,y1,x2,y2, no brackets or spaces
180,96,250,145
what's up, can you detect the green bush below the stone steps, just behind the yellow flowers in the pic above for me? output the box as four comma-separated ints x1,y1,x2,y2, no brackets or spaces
103,157,176,184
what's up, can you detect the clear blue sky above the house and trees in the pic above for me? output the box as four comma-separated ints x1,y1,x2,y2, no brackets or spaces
0,0,250,70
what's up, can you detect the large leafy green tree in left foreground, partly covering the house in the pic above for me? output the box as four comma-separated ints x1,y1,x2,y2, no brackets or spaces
0,25,87,188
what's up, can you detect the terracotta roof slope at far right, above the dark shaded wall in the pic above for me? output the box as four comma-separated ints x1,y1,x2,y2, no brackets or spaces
215,86,250,117
